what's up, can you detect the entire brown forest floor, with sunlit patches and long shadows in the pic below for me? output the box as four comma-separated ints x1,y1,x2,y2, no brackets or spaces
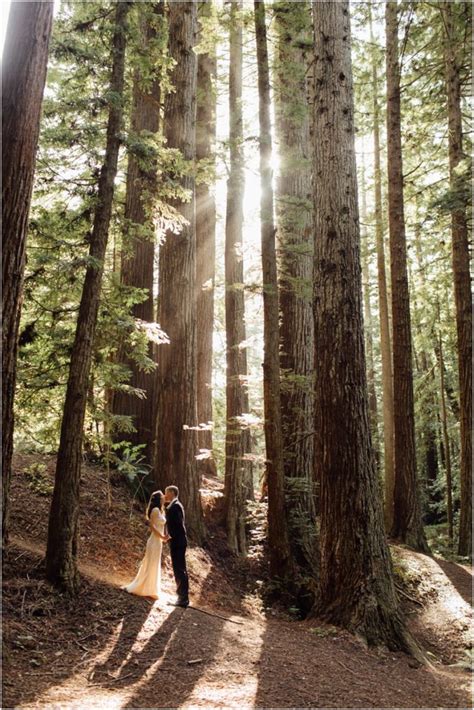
2,455,472,710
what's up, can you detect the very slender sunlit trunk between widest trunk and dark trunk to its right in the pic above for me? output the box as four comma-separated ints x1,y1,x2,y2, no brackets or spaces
369,4,395,532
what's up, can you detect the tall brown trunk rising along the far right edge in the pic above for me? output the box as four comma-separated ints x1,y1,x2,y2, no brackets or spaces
440,3,472,557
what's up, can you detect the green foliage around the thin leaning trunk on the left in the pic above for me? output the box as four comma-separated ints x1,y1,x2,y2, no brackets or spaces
16,2,189,455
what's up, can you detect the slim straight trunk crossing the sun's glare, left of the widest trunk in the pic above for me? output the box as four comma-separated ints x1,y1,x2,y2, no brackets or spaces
254,0,293,579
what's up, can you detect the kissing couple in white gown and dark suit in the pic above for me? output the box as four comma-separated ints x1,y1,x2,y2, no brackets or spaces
123,486,189,608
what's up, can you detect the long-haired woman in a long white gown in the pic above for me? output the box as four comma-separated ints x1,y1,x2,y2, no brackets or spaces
122,491,169,599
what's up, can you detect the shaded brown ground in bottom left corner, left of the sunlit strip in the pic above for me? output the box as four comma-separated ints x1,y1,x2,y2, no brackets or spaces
2,544,150,707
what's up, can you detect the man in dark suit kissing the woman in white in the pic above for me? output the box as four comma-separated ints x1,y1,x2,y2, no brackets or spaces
165,486,189,609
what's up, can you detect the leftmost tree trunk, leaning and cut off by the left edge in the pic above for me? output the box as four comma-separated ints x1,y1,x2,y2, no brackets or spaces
2,2,54,544
